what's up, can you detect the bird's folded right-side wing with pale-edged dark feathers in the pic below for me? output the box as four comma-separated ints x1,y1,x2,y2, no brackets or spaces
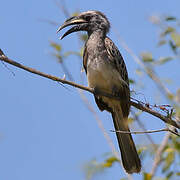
105,37,130,117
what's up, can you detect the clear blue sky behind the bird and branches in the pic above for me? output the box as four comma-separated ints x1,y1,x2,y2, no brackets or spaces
0,0,180,180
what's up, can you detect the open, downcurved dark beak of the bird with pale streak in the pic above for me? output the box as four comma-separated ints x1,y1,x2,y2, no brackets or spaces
57,16,87,39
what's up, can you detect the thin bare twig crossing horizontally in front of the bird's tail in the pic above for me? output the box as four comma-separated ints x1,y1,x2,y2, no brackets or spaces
111,128,180,137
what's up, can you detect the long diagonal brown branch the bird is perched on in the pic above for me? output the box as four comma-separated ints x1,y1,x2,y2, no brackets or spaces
0,49,180,129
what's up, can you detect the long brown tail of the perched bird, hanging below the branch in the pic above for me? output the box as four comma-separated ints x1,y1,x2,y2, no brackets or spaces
112,109,141,174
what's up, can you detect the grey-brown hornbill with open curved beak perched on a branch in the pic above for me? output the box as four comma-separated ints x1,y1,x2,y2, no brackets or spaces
57,11,141,173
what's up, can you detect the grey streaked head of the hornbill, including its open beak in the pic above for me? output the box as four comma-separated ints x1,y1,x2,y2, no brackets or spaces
57,11,110,39
